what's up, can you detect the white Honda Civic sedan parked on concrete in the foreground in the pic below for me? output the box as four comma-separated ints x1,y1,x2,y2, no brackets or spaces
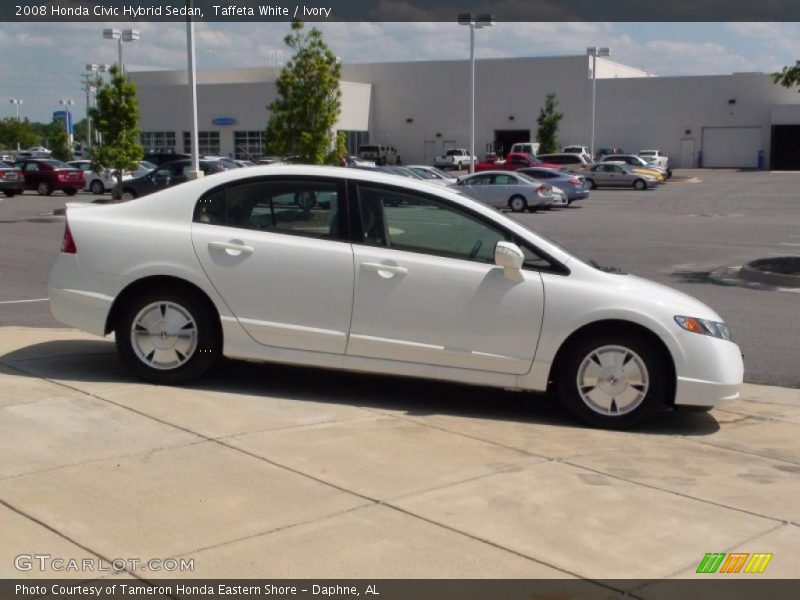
50,165,743,427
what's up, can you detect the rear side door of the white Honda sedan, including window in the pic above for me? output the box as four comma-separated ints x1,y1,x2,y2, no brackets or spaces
192,177,354,354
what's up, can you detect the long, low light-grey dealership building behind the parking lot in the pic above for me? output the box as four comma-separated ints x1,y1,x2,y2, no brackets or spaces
130,55,800,170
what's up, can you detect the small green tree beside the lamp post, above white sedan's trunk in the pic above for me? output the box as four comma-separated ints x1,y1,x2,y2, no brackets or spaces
89,65,144,182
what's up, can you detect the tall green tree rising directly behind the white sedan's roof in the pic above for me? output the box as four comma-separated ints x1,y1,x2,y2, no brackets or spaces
266,21,347,165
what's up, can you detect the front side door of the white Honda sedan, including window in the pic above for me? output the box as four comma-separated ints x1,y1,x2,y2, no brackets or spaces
347,183,544,374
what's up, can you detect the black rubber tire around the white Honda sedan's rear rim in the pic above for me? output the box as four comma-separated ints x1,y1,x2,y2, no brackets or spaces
115,287,222,385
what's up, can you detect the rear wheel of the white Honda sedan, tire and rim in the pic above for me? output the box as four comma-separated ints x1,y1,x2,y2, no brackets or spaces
116,289,221,385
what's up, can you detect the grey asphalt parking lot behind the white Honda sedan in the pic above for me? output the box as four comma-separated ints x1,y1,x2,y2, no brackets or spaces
0,170,800,388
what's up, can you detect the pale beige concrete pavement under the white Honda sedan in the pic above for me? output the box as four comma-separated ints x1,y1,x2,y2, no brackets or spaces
0,327,800,597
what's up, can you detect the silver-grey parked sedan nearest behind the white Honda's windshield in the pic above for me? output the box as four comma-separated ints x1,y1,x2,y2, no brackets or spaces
456,171,553,212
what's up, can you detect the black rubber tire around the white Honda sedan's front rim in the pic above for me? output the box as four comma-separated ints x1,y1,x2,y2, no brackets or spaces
554,331,669,429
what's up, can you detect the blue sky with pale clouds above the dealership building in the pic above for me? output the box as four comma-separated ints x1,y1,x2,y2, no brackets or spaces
0,22,800,121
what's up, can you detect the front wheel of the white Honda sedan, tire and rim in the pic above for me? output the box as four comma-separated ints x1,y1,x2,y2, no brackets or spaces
555,332,669,429
